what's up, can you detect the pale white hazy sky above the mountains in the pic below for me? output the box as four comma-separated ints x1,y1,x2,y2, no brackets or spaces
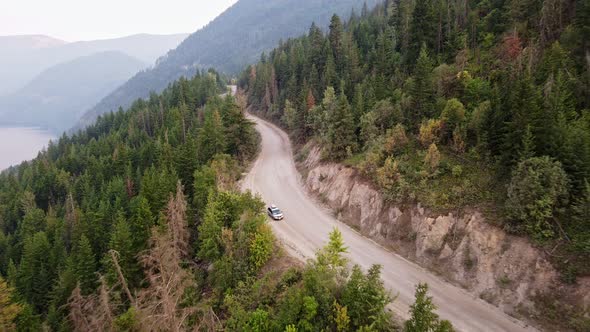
0,0,237,41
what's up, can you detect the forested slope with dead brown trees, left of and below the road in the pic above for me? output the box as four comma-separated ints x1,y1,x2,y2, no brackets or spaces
0,67,444,332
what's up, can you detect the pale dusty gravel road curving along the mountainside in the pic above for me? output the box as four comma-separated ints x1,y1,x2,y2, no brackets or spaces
242,115,535,332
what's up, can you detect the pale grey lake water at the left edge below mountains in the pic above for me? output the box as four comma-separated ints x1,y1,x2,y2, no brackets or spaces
0,127,54,171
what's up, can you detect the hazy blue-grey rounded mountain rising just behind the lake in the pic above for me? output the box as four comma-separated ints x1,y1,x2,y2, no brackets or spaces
0,51,147,133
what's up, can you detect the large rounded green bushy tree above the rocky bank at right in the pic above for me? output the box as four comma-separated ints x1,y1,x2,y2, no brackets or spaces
506,157,568,240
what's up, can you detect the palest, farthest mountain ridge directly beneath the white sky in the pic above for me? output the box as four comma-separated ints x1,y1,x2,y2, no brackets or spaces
0,34,188,96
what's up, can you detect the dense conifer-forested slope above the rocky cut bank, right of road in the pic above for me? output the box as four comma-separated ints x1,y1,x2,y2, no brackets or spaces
239,0,590,326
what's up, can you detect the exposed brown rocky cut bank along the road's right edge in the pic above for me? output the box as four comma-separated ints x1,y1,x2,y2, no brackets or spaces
298,147,590,328
